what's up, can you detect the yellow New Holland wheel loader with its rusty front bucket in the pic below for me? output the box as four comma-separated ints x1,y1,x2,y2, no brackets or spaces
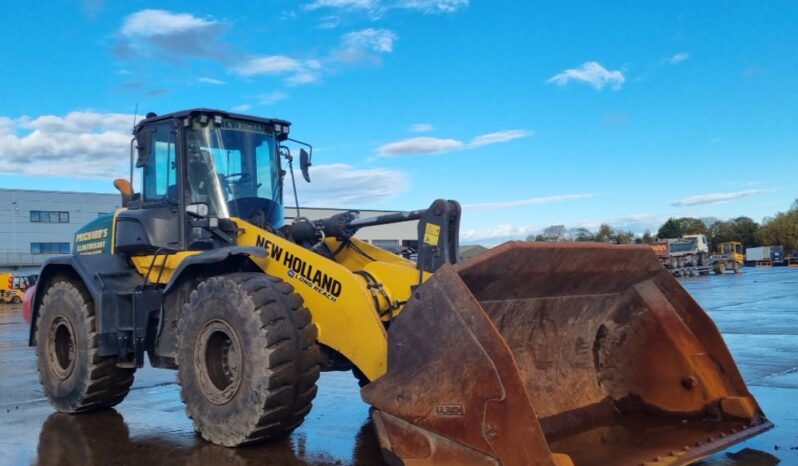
30,109,772,466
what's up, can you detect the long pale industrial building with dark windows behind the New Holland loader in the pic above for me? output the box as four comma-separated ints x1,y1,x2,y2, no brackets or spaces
0,188,418,275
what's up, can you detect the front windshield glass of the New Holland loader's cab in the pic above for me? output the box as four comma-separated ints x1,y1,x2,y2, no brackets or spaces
186,119,282,218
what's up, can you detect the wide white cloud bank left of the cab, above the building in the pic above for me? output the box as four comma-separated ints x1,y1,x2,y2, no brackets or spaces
0,111,133,178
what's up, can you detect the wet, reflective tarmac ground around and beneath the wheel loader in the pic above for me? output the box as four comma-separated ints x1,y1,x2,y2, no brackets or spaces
0,267,798,466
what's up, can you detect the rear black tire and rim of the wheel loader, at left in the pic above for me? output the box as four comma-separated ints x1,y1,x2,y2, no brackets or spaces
36,278,135,413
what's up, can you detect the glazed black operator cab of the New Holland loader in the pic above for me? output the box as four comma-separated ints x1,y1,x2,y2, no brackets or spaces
116,109,291,254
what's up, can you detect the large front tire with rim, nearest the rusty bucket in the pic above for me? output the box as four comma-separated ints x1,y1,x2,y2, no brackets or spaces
177,273,320,447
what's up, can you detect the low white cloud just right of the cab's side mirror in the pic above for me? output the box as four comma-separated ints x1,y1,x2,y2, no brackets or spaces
285,163,409,209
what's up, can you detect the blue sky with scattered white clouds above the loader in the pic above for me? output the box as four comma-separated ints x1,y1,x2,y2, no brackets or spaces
0,0,798,243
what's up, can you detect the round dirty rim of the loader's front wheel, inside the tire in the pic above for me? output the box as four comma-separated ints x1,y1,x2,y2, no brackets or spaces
194,320,243,404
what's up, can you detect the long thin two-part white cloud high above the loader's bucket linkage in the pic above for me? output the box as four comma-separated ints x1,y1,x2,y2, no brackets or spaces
377,129,534,156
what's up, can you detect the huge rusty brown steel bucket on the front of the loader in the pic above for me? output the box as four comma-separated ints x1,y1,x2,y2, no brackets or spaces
362,242,772,466
